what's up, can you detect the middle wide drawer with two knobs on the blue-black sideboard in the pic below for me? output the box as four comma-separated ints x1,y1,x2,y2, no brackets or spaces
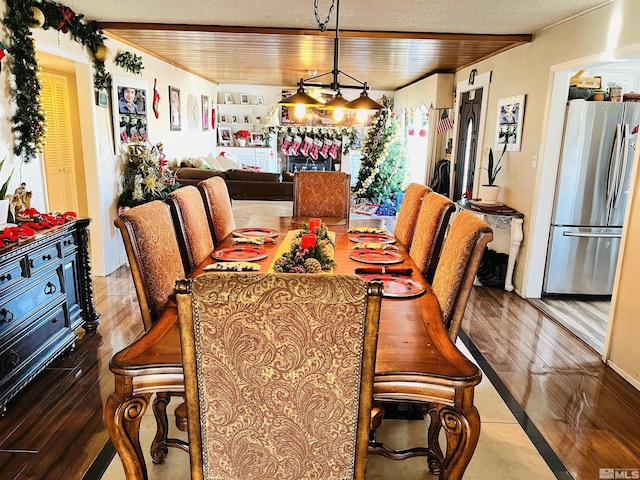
0,267,64,338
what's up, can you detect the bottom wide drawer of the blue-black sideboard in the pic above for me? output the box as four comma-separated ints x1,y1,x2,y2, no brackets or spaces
0,306,74,390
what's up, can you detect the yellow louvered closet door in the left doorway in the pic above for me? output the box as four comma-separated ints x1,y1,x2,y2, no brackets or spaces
41,73,78,212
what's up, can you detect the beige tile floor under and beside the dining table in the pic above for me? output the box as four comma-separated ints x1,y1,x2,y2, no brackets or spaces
102,340,556,480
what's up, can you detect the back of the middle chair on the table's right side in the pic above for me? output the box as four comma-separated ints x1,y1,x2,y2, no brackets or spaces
409,192,456,283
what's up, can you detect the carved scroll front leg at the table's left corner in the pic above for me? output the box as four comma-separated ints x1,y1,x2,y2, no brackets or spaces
104,393,151,480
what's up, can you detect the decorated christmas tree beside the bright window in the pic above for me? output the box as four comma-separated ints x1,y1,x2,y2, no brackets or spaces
353,97,407,203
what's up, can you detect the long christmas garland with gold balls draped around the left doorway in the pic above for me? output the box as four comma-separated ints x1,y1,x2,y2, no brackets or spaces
3,0,109,163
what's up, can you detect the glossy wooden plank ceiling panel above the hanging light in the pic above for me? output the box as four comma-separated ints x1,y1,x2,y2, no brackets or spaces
100,22,532,91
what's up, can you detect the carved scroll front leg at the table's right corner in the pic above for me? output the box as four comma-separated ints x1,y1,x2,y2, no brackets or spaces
437,405,480,480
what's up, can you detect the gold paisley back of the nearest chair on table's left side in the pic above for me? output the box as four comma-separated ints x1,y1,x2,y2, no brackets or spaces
114,200,185,330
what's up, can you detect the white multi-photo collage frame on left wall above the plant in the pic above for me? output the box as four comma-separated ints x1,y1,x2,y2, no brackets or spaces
112,75,149,150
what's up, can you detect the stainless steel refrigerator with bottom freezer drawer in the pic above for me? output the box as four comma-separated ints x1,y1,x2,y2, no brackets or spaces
543,101,640,295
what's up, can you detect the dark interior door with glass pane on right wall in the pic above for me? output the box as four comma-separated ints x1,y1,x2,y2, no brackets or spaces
453,88,482,201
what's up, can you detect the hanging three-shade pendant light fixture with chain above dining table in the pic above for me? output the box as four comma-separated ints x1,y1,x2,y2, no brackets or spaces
279,0,383,110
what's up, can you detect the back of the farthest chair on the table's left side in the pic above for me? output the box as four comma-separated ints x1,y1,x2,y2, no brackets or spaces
198,177,236,246
